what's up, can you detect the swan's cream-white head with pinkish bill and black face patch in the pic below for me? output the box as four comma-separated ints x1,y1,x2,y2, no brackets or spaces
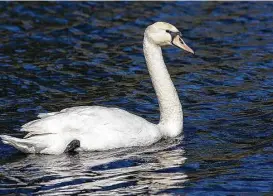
144,22,194,54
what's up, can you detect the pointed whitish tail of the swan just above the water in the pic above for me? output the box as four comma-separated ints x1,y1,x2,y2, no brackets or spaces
0,135,40,153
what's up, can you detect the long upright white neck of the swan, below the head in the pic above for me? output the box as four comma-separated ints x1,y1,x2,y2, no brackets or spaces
143,35,183,137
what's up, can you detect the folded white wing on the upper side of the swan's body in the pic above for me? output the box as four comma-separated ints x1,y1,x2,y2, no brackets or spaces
21,106,154,138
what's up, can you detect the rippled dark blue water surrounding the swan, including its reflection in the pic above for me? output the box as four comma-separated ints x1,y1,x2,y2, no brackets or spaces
0,2,273,195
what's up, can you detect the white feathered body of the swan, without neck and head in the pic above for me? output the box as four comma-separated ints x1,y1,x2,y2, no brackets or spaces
2,106,161,154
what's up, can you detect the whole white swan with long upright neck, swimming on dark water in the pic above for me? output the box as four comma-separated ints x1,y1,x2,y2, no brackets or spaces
0,22,194,154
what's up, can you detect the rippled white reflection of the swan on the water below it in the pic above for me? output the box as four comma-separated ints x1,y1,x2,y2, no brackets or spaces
0,139,187,195
